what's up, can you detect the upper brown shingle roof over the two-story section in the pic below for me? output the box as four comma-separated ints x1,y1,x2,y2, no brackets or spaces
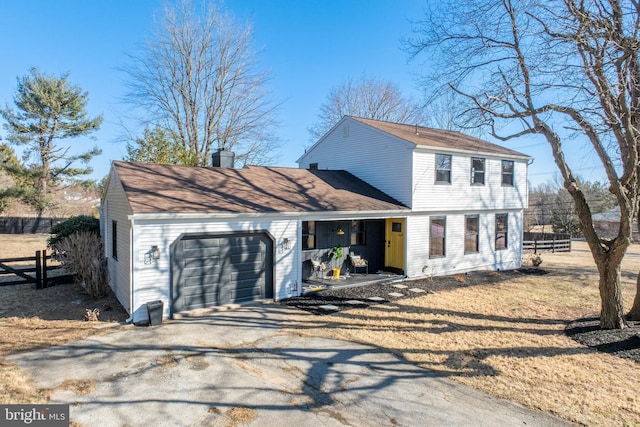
349,116,529,157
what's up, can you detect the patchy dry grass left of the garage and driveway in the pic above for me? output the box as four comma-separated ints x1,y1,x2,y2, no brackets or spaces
0,234,126,404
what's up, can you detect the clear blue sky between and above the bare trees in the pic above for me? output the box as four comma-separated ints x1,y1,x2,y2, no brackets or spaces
0,0,602,184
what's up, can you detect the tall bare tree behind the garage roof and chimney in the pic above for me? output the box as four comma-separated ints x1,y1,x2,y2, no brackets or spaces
124,0,277,166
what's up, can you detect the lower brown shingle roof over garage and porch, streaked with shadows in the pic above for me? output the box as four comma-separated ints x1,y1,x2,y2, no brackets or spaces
113,161,407,213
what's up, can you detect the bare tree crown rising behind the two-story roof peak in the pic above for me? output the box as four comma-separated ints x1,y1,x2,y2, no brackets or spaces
309,75,424,142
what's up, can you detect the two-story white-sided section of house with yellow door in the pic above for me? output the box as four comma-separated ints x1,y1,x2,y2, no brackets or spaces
298,116,532,277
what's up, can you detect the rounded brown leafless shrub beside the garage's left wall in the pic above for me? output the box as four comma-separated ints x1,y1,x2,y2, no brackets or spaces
54,231,109,298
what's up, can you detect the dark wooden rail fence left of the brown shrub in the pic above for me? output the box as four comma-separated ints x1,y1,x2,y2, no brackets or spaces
0,251,72,289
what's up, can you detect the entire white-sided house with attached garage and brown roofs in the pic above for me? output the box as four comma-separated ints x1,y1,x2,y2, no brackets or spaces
101,117,531,321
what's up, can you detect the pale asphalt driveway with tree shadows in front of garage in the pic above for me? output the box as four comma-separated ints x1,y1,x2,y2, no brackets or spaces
9,304,568,427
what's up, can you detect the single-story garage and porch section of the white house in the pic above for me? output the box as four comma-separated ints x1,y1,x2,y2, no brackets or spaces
101,161,408,316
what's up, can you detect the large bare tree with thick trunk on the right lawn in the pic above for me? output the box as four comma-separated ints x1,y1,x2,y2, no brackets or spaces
409,0,640,329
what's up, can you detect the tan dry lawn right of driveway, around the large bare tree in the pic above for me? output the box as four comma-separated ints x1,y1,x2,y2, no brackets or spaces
298,243,640,426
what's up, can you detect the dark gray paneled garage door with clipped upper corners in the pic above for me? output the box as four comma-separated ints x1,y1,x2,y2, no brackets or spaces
171,233,273,313
